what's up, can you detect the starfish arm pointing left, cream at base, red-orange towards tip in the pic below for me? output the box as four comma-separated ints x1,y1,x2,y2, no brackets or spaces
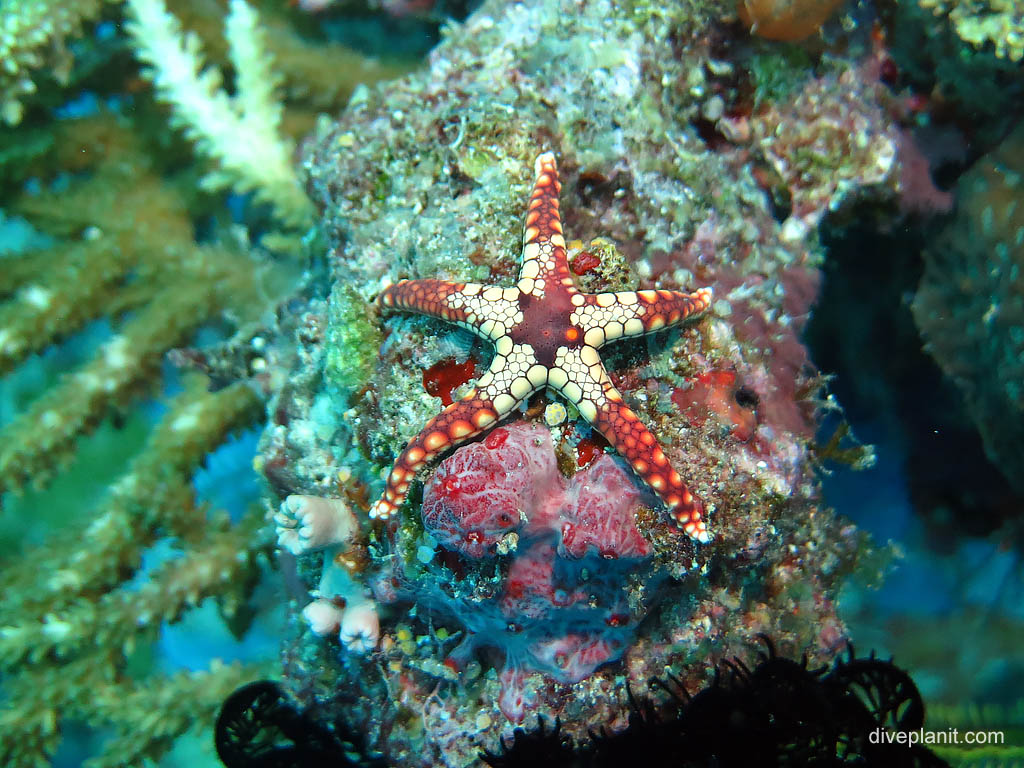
377,280,521,340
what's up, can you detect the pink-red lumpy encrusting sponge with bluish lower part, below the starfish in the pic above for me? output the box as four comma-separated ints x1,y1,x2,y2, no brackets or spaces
422,423,656,722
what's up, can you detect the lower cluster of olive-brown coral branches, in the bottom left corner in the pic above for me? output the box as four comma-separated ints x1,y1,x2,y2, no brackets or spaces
0,381,268,767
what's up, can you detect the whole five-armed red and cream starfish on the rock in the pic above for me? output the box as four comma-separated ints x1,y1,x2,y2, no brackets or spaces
370,152,711,542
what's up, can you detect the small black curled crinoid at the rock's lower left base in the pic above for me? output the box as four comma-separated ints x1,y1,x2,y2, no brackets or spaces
214,680,384,768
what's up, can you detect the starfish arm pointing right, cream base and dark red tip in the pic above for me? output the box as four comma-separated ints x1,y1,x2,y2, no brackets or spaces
569,288,711,347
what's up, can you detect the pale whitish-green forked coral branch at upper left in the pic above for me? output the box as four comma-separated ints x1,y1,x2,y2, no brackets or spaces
128,0,312,226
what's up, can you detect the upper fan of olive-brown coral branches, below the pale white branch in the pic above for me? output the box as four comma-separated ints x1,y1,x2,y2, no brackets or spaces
0,131,296,492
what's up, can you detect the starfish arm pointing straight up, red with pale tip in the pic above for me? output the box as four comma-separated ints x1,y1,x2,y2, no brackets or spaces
518,152,574,296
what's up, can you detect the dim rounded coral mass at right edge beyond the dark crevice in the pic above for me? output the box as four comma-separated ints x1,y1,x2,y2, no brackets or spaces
912,120,1024,493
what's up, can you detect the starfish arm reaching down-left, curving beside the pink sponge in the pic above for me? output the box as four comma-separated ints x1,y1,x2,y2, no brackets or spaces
370,354,537,519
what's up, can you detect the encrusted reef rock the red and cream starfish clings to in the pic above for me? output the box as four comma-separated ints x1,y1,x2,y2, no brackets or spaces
261,2,898,766
